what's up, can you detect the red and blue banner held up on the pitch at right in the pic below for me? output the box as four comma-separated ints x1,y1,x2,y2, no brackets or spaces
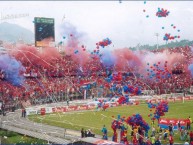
158,118,186,130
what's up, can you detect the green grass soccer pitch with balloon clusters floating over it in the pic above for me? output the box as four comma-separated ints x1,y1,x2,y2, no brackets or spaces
29,101,193,142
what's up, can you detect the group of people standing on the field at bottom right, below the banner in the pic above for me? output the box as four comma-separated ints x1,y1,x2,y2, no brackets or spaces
98,116,193,145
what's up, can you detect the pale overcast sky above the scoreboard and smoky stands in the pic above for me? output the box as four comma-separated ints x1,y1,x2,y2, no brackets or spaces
0,0,193,48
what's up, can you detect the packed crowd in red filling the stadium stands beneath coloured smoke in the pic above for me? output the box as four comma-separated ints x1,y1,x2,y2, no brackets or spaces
0,46,193,110
